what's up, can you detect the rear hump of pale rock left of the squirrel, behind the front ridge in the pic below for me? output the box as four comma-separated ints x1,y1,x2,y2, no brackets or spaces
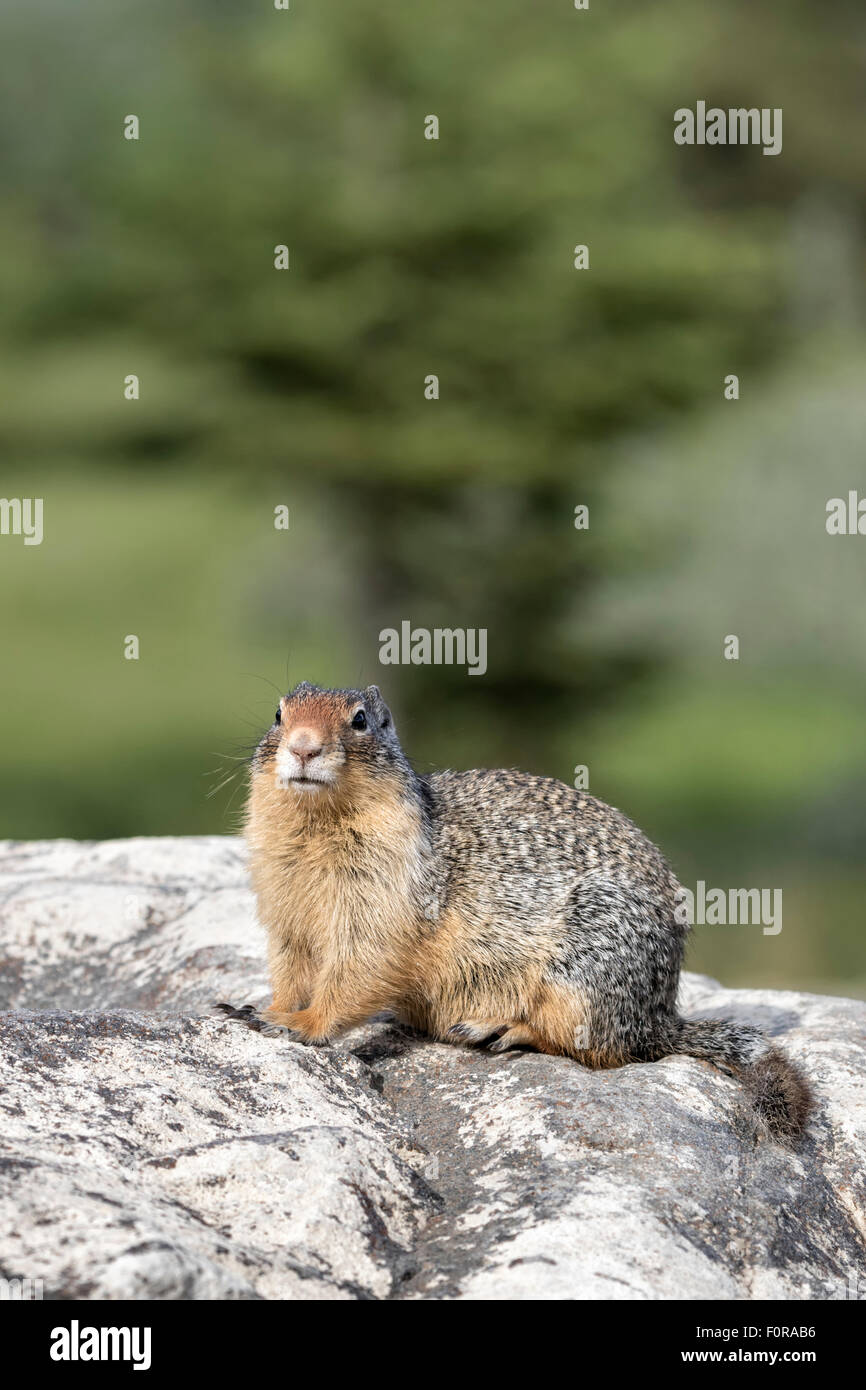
0,835,267,1013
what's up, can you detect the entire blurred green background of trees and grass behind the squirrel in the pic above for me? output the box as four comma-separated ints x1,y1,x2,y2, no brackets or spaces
0,0,866,995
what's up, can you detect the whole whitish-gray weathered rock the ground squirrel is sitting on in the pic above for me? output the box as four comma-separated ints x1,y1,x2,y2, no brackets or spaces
0,837,866,1300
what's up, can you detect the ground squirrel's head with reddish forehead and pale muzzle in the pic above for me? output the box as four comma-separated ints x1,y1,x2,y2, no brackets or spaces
254,681,406,801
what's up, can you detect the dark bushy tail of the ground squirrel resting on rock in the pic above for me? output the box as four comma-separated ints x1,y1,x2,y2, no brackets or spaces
671,1019,813,1143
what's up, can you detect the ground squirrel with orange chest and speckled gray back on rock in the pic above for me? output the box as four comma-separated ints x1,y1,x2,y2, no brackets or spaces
220,681,810,1138
